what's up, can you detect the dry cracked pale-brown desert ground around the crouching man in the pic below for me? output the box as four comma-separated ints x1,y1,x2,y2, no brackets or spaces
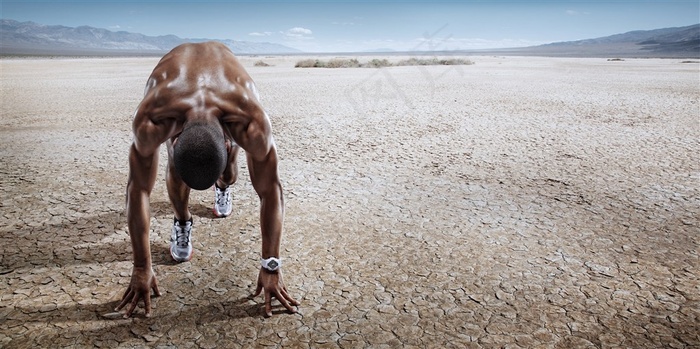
0,56,700,348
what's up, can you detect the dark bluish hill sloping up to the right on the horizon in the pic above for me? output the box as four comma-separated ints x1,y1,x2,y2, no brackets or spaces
508,24,700,58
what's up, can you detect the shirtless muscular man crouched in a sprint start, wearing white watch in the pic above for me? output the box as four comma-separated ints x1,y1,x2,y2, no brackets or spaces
116,42,299,317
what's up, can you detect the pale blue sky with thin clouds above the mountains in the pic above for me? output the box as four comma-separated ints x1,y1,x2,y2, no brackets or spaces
0,0,700,52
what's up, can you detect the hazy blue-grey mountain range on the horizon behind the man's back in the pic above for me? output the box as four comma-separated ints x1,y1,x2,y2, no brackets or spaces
0,19,301,55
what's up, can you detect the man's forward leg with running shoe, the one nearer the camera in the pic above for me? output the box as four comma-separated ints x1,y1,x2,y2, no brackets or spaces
165,140,193,262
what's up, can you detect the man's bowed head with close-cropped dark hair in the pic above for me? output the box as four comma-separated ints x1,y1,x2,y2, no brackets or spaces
173,122,228,190
